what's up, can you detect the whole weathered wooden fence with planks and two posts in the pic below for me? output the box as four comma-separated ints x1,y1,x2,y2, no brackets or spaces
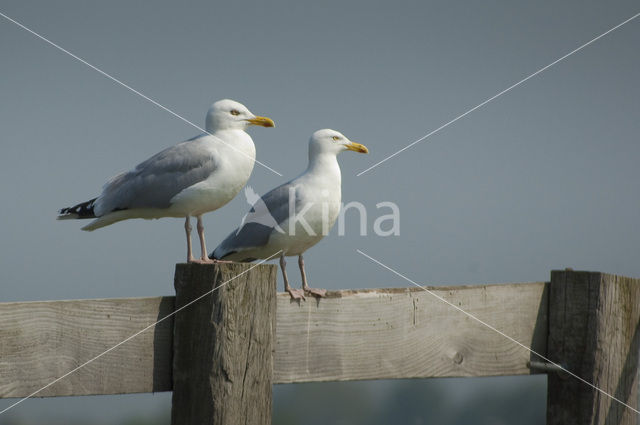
0,264,640,425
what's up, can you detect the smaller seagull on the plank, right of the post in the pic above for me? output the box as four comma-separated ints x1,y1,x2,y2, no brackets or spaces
210,129,369,300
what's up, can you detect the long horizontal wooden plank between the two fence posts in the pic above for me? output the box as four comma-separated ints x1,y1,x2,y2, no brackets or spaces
274,282,547,383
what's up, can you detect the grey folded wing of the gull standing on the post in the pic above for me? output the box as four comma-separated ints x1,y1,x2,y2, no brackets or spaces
96,137,218,215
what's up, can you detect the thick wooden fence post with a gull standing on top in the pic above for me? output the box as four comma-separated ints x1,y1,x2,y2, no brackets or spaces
171,264,277,425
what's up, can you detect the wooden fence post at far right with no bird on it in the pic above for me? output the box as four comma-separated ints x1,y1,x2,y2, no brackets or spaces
547,271,640,425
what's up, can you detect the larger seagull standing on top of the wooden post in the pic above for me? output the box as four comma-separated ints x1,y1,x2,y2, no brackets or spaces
58,99,274,263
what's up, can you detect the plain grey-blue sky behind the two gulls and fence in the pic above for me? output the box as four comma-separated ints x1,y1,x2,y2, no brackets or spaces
0,0,640,422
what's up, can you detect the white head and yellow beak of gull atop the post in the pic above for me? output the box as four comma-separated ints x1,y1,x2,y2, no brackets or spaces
206,99,275,133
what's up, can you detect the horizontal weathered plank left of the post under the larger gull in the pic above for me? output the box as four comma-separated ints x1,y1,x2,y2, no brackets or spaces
0,297,174,398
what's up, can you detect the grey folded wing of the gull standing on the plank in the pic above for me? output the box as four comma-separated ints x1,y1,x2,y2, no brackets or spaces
211,182,302,261
